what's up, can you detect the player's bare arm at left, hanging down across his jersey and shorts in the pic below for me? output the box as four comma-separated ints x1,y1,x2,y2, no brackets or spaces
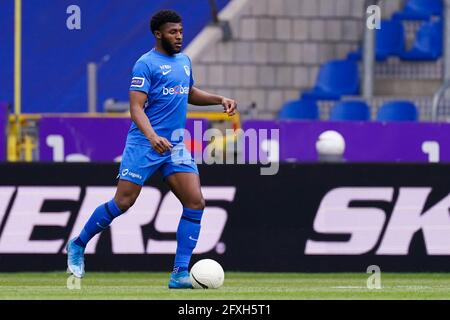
130,90,173,153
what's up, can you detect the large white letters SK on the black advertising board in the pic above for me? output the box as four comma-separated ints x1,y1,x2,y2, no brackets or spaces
305,187,450,256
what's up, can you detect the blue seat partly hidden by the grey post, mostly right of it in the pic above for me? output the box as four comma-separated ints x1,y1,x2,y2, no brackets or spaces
348,20,405,61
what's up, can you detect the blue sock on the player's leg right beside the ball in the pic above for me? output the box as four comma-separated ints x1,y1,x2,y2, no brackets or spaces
173,208,203,273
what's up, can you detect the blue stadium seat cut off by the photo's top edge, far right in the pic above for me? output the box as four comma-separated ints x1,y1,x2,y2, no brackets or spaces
393,0,443,20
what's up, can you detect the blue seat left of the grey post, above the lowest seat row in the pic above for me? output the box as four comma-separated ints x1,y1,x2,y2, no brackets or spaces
302,60,359,100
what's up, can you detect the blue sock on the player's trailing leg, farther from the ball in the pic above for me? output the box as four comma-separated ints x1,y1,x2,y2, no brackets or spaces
75,199,123,247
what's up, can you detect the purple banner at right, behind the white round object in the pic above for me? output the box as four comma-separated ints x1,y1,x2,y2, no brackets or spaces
243,120,450,162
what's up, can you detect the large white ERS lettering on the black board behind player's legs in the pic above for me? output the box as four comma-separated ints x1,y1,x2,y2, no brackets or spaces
0,186,236,254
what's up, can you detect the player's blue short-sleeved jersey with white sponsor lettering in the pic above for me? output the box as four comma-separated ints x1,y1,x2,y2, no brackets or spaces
127,49,194,146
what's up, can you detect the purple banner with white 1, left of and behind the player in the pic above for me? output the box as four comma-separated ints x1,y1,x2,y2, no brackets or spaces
39,117,208,162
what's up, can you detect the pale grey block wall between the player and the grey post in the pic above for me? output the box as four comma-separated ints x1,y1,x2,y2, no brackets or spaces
186,0,370,119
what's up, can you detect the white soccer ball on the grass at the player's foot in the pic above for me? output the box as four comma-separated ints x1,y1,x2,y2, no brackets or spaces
190,259,225,289
